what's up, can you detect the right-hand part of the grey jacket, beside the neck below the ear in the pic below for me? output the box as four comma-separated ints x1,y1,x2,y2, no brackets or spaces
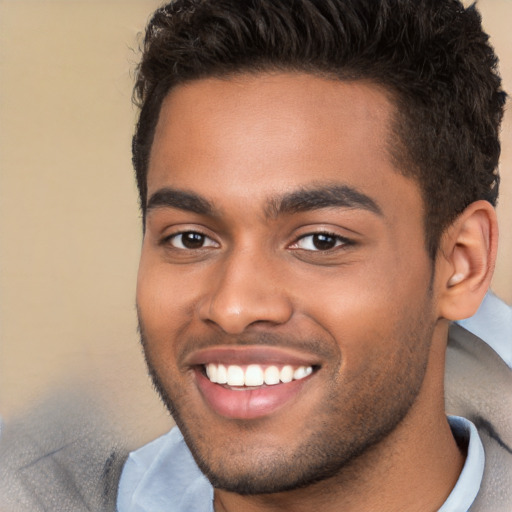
445,325,512,512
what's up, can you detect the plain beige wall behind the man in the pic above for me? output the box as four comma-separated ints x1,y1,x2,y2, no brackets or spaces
0,0,512,446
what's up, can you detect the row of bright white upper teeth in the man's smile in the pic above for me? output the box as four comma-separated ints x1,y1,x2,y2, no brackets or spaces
206,363,313,387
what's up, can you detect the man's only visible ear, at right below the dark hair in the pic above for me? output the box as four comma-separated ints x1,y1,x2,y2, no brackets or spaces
436,201,498,320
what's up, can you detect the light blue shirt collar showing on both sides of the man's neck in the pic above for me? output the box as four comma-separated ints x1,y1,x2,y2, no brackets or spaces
117,416,485,512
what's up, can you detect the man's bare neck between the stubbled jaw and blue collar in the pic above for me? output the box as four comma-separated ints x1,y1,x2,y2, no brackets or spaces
215,322,465,512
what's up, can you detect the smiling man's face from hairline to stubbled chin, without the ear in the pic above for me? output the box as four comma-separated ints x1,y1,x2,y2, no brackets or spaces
137,73,436,493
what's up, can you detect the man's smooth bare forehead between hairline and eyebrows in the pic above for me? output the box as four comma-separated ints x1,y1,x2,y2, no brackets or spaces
148,73,416,214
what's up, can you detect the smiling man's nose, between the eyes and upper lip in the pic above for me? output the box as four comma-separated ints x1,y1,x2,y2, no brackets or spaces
199,253,292,335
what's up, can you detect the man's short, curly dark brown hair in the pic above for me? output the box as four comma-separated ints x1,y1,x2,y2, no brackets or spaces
133,0,506,258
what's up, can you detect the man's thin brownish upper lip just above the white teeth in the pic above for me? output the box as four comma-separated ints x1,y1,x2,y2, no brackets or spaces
184,346,320,366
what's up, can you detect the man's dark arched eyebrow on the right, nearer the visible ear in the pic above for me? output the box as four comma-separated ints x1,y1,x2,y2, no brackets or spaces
266,184,383,217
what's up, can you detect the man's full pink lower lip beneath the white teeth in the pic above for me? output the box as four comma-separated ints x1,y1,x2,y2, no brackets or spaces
196,369,311,420
